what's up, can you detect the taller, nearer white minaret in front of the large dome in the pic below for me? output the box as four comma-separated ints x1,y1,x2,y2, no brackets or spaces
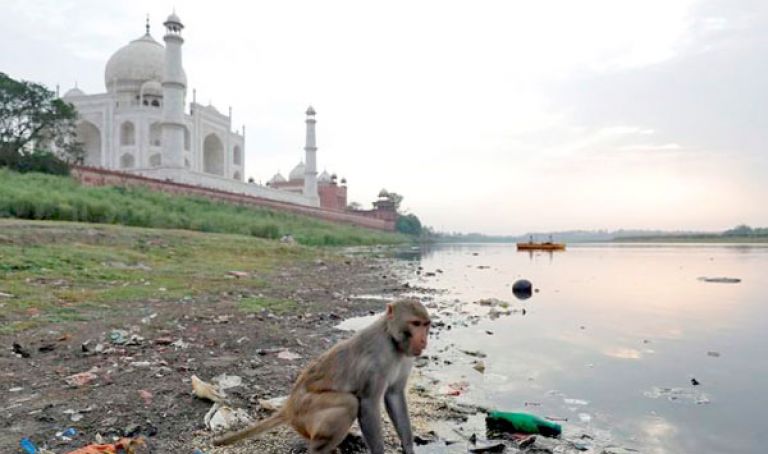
162,11,187,168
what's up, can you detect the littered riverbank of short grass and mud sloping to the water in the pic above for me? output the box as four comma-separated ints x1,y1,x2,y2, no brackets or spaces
0,221,428,453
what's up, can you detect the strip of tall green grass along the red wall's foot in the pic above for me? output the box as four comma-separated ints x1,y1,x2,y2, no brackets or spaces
0,169,408,246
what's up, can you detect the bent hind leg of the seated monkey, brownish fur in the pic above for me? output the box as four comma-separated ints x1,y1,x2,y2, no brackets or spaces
300,392,358,454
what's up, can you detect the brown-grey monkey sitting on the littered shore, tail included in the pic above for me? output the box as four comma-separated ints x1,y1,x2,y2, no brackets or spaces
213,299,431,454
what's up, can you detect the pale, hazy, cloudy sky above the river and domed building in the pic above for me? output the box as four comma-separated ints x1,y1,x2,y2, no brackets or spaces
0,0,768,234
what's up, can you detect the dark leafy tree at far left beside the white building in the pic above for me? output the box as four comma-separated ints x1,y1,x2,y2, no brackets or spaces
0,72,84,163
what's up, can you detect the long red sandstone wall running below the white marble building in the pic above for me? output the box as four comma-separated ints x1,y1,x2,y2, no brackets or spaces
72,167,395,232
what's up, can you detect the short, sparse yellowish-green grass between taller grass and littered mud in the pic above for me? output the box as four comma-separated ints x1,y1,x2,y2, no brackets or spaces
0,220,325,334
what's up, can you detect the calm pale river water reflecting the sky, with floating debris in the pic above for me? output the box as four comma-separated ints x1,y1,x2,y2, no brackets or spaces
350,245,768,453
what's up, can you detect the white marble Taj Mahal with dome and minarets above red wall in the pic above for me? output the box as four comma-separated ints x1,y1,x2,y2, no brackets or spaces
63,12,346,209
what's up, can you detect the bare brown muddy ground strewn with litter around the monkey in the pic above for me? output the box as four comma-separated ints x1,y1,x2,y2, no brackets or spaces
0,250,444,453
